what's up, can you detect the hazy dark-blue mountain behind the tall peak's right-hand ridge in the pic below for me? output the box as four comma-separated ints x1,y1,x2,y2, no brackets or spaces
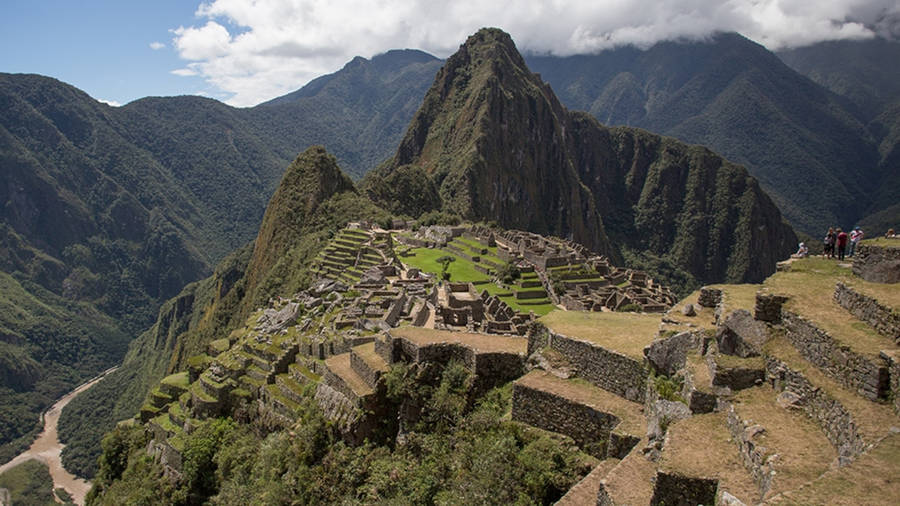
527,34,880,236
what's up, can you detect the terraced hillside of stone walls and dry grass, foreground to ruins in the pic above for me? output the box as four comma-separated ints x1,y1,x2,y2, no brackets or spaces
88,231,900,505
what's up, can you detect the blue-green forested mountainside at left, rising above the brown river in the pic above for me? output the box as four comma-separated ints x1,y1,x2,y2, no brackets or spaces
0,51,439,460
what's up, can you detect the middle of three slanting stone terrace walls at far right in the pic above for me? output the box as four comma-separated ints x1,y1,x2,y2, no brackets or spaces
782,311,888,401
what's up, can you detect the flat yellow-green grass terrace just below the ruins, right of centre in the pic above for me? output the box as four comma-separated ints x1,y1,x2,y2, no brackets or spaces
540,311,662,361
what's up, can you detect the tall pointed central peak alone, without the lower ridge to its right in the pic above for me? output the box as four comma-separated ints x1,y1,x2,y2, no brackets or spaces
366,30,613,253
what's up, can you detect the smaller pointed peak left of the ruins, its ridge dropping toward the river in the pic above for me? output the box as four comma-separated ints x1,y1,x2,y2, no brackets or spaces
60,146,389,476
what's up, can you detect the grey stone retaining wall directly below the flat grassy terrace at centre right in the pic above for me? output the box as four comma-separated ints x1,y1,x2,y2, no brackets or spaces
529,331,649,403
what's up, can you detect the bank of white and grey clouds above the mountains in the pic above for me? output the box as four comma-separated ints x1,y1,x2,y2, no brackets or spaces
172,0,900,106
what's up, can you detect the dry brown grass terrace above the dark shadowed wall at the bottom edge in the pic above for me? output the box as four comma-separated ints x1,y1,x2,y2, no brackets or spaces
659,412,759,504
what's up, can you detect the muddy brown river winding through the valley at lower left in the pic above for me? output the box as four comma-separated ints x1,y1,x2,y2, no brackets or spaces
0,367,118,504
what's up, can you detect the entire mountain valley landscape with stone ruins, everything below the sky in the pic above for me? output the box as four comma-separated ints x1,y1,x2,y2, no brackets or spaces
0,16,900,505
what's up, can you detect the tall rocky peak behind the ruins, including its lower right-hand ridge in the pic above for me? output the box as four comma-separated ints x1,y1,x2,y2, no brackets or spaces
363,29,796,288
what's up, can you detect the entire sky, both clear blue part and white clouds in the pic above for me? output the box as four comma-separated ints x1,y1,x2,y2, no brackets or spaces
0,0,900,106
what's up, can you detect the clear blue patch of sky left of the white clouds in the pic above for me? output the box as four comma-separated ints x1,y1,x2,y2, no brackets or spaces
0,0,211,104
